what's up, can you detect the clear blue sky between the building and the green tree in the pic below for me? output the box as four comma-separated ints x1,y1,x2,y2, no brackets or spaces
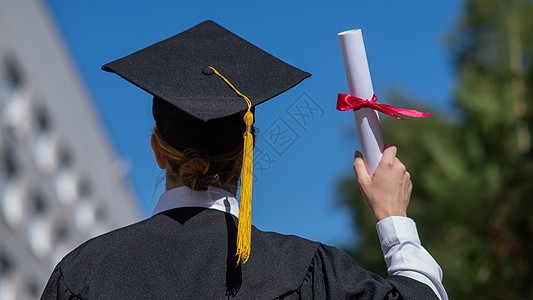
48,0,462,246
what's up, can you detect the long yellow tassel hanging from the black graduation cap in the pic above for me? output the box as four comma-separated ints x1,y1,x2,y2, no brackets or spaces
209,67,254,264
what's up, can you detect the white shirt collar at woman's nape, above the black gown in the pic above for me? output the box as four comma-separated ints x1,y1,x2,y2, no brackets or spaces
152,186,239,218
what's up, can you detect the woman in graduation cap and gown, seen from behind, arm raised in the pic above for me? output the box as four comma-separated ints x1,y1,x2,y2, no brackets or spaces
42,21,447,299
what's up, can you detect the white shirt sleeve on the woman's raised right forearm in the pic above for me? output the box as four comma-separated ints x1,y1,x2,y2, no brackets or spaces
376,217,448,300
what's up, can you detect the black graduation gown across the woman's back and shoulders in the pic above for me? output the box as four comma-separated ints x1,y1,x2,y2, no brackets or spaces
41,207,437,299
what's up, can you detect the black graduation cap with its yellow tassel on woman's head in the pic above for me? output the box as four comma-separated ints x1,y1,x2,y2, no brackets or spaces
102,20,311,261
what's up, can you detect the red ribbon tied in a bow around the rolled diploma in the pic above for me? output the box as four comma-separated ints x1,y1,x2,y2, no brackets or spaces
337,94,435,120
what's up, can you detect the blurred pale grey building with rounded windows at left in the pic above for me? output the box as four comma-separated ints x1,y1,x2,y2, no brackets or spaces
0,0,141,299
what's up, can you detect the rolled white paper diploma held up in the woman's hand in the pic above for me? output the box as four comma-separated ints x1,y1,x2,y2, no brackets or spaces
338,29,384,174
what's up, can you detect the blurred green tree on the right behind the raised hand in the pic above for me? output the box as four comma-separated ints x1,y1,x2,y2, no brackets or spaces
340,0,533,299
